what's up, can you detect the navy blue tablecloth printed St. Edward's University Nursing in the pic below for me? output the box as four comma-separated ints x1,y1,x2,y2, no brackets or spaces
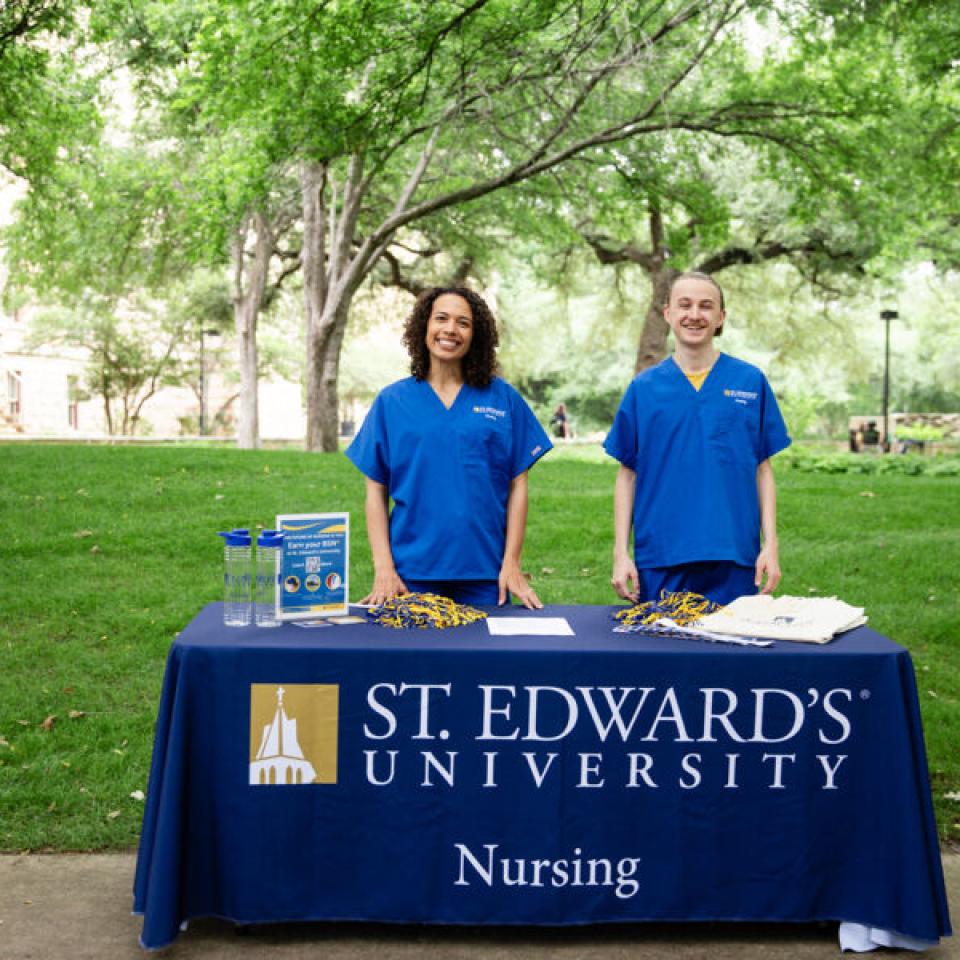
134,604,950,947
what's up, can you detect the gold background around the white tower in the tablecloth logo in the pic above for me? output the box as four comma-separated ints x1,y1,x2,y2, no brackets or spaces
250,683,340,783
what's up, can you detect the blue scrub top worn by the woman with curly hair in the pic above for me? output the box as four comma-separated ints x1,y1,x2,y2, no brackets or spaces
347,377,553,580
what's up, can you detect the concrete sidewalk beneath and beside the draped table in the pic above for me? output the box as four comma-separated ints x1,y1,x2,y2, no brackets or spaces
0,853,960,960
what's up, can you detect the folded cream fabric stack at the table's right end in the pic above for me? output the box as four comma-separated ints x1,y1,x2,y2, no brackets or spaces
696,594,867,643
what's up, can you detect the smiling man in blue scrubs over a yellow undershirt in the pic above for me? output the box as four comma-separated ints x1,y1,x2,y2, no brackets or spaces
604,272,790,604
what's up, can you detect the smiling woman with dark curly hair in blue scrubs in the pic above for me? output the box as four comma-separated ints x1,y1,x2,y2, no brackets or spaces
347,287,552,608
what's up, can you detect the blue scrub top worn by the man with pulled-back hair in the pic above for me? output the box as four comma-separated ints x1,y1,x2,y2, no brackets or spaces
603,353,790,568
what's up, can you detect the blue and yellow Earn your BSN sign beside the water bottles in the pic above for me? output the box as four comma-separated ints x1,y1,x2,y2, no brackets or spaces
277,513,350,620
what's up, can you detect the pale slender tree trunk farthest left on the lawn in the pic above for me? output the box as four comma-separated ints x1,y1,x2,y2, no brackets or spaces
233,213,274,450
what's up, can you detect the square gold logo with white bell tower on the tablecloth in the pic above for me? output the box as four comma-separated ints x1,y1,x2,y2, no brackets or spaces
249,683,340,787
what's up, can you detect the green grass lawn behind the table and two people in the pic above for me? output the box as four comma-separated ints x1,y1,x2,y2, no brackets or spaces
0,444,960,851
